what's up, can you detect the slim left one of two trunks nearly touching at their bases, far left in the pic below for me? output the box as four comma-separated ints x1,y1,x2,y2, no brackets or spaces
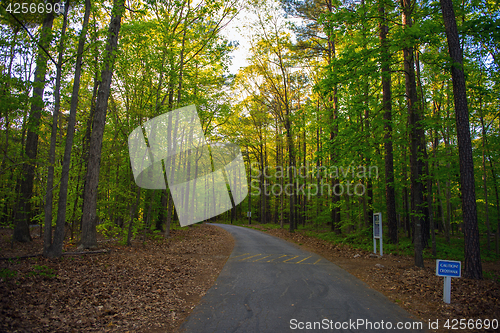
43,0,69,257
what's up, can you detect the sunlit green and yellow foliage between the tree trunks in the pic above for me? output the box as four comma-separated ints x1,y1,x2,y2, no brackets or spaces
0,0,500,268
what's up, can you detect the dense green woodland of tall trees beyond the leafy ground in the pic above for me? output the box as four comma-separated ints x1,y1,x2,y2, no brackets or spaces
0,0,500,278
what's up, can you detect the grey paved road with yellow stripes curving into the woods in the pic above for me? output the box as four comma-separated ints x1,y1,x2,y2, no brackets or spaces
181,224,427,333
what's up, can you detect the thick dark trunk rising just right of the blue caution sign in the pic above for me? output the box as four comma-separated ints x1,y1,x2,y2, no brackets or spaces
440,0,483,279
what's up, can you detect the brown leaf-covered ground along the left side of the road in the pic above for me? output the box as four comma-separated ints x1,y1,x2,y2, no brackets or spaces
0,225,234,332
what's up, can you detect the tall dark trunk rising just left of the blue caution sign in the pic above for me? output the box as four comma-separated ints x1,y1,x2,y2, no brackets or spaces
401,0,425,267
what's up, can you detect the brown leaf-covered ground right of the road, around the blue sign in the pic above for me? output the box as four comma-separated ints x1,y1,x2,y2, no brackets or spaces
249,226,500,332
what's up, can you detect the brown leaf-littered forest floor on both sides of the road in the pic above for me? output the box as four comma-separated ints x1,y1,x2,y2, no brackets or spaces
0,225,500,332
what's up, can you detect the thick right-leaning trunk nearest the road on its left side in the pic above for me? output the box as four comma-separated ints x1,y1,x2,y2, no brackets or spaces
80,0,125,248
